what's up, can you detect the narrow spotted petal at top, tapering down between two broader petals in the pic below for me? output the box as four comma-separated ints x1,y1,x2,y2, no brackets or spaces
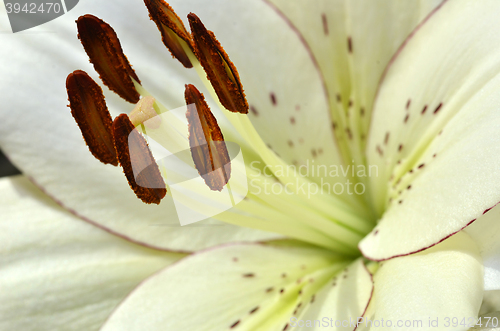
269,0,441,164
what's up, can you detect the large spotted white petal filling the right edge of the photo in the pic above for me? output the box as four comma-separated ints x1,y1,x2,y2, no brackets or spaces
360,1,500,260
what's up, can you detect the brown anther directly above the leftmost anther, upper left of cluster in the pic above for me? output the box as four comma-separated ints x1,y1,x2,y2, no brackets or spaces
76,14,140,103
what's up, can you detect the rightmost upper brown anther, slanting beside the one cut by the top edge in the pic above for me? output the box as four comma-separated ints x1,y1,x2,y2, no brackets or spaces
188,13,248,114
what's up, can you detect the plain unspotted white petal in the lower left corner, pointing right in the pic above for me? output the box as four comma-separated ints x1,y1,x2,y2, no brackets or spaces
0,176,183,331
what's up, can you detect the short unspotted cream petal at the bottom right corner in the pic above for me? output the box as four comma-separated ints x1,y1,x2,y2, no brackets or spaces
362,232,483,330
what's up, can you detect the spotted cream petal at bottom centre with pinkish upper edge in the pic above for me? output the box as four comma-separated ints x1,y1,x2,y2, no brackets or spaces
103,245,352,331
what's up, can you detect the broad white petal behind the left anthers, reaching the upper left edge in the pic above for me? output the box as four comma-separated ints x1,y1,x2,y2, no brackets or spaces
0,0,277,251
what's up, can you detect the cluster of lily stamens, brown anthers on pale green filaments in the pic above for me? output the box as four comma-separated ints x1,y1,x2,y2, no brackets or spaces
68,0,375,257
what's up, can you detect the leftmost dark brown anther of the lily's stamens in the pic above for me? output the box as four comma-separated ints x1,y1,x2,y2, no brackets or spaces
66,70,118,166
